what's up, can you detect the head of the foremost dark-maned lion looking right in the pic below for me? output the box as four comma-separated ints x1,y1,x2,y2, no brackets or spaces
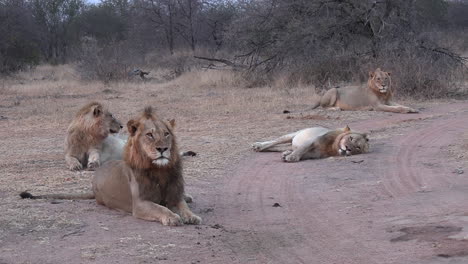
124,107,180,169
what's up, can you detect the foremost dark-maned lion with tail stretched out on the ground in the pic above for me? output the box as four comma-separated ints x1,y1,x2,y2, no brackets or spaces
20,107,202,226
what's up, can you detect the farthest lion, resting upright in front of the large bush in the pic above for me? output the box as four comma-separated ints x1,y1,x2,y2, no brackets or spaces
312,68,418,113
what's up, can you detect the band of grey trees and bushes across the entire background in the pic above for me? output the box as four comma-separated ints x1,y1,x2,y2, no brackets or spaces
0,0,468,97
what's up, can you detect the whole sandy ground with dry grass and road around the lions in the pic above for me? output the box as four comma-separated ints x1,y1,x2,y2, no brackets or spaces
0,65,468,264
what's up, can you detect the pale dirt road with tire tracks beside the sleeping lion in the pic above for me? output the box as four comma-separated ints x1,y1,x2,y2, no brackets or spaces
207,104,468,263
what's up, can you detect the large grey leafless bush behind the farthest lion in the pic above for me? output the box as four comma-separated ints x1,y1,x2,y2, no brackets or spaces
225,0,464,97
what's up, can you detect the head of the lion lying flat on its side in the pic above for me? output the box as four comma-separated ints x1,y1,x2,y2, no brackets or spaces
338,126,369,156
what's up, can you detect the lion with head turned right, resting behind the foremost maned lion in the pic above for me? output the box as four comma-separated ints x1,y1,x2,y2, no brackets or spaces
65,102,122,170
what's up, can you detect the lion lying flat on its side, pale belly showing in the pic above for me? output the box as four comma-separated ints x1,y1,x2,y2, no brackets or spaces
252,126,369,162
